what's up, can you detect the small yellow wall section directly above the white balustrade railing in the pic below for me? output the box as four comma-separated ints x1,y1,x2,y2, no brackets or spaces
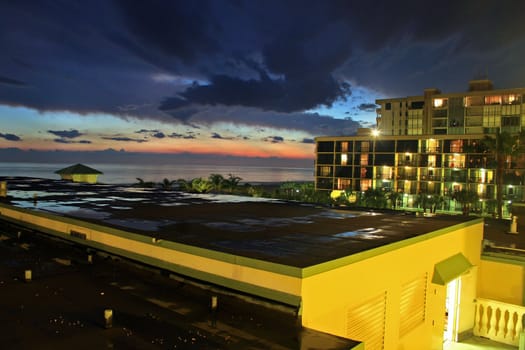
478,258,525,305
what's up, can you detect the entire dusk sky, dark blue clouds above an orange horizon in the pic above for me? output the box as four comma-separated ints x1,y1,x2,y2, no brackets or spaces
0,0,525,164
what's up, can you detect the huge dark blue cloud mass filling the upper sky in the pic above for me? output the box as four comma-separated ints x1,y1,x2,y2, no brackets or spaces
0,0,525,135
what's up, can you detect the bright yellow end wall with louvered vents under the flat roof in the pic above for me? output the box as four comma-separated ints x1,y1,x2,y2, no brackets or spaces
302,220,483,350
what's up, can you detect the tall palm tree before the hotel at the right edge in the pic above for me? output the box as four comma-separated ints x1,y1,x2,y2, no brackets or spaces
483,131,525,219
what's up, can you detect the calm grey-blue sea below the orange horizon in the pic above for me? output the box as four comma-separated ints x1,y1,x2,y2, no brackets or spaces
0,163,313,184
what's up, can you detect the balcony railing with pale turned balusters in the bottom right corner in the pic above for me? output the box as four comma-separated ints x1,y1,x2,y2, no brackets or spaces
474,298,525,346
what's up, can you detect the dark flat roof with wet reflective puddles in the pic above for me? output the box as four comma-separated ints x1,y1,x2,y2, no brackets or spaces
0,177,478,268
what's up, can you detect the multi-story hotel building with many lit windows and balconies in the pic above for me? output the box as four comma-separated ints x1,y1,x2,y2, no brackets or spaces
315,80,525,214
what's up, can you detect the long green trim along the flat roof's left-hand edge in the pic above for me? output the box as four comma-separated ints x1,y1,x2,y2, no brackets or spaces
0,203,302,278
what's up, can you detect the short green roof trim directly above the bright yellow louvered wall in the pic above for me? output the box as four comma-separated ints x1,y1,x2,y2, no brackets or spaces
302,218,483,278
